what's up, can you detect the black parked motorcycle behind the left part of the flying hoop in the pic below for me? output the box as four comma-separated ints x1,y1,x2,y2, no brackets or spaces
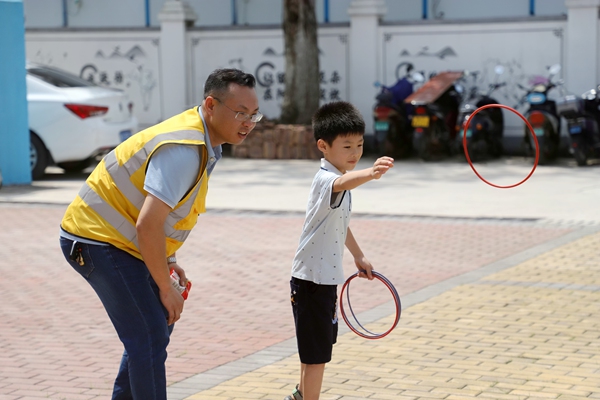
456,65,506,161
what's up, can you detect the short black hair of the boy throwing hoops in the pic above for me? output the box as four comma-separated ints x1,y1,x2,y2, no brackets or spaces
312,101,365,146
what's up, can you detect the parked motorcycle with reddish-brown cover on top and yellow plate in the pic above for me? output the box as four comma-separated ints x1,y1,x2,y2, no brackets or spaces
404,71,463,161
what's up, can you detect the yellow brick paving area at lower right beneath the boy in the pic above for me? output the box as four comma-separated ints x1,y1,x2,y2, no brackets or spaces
178,227,600,400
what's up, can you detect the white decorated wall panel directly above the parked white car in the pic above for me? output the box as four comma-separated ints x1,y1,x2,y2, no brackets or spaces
26,35,161,126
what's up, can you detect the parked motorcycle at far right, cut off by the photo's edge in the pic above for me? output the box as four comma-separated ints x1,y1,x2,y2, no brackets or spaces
556,86,600,166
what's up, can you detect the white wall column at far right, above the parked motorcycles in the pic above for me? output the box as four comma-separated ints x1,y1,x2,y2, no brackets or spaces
564,0,600,95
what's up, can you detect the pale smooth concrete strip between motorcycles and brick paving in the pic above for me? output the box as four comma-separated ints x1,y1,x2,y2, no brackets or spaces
0,157,600,223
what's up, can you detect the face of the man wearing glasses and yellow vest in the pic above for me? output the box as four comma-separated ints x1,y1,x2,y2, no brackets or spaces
206,83,258,146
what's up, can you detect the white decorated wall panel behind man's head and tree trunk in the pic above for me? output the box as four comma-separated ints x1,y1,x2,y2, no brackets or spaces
191,31,349,119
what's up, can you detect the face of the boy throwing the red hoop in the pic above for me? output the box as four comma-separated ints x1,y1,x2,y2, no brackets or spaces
317,133,365,174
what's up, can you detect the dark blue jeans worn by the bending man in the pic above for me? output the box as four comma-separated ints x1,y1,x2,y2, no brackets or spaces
60,237,174,400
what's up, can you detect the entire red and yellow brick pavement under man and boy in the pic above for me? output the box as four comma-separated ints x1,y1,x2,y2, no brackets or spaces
0,158,600,400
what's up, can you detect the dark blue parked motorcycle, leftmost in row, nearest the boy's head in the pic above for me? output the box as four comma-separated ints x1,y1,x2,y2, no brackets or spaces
373,63,424,158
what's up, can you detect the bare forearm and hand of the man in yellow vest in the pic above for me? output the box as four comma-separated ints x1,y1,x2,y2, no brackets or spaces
136,194,183,325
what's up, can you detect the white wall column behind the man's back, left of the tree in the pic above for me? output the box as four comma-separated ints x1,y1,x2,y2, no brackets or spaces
158,0,196,119
